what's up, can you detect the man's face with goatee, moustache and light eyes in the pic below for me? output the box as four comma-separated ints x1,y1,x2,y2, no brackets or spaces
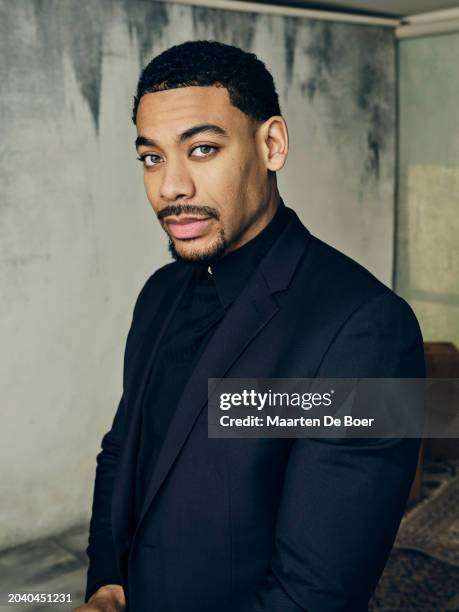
136,86,270,261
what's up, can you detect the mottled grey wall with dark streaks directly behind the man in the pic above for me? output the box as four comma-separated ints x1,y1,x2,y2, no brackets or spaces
0,0,395,546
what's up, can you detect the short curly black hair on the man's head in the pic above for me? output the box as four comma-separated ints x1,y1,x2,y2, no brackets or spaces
132,40,281,124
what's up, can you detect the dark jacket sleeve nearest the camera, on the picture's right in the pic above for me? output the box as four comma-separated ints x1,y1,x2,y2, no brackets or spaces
230,291,425,612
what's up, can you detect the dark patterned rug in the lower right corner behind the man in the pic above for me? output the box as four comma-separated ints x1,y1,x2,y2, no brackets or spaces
369,462,459,612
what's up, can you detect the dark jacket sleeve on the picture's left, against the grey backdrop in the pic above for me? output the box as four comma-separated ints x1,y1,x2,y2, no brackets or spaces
85,273,156,602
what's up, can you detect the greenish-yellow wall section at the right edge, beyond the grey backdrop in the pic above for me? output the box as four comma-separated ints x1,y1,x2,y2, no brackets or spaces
396,34,459,347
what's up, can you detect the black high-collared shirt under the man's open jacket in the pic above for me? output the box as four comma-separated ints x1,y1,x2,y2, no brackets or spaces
136,199,289,512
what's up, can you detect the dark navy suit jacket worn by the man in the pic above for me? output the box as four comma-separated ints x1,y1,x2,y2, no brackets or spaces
86,211,425,612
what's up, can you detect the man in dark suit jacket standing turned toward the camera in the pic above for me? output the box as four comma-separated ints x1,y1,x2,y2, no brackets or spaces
79,41,424,612
